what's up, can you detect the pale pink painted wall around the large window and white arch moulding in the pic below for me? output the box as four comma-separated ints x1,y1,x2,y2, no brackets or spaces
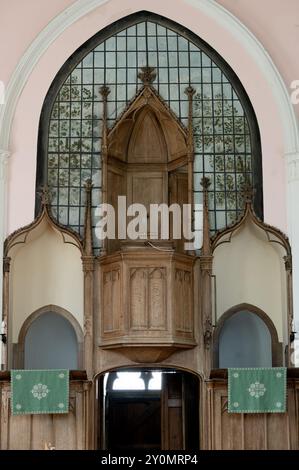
0,0,299,233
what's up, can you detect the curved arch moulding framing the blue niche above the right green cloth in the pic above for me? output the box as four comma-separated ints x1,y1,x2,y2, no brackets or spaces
213,303,283,368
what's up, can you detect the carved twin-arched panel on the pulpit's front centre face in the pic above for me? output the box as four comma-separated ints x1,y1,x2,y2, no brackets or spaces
129,267,167,330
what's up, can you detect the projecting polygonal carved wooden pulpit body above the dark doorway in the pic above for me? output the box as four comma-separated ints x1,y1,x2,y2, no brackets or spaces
98,247,196,363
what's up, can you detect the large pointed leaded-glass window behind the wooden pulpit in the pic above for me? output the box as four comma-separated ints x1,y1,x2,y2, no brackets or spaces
37,12,262,251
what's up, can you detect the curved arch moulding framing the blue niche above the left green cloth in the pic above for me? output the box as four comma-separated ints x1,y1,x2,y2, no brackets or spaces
13,305,84,369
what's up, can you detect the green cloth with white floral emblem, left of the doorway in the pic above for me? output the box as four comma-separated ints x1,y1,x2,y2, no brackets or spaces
11,369,69,415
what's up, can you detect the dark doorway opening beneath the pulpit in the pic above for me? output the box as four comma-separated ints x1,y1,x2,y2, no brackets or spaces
97,368,199,451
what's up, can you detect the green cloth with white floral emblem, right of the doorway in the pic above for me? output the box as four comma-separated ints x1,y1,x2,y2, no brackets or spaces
228,367,287,413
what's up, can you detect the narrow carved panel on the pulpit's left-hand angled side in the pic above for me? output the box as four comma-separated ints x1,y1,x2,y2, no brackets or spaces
103,268,122,333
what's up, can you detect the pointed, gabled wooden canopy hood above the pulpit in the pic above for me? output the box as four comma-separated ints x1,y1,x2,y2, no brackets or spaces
108,81,188,163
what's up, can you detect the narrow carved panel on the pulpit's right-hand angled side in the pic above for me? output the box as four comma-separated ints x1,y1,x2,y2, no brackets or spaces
174,268,193,333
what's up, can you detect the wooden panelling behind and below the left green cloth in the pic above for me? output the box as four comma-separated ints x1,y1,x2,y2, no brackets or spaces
0,371,93,450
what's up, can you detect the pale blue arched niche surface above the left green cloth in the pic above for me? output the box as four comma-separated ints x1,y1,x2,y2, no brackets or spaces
24,312,79,370
